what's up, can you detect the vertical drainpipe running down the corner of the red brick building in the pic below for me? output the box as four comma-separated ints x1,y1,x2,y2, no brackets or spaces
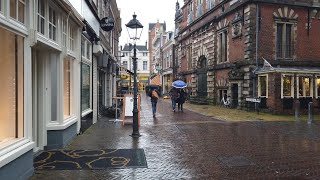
252,3,260,97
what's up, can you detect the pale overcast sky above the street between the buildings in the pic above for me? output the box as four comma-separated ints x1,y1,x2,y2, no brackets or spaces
116,0,183,46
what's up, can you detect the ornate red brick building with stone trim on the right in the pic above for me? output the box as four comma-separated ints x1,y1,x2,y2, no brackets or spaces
175,0,320,113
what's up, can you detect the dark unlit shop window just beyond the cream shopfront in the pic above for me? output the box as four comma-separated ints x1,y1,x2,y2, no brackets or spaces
81,63,91,111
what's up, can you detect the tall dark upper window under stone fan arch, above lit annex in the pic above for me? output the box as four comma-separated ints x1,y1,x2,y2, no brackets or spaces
276,23,294,59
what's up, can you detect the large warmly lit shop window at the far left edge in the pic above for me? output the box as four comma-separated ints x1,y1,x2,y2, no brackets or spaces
0,27,24,146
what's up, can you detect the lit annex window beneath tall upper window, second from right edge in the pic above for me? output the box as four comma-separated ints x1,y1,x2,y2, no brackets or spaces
297,77,313,97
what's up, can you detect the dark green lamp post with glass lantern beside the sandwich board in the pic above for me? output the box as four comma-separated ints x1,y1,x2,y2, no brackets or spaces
126,14,143,137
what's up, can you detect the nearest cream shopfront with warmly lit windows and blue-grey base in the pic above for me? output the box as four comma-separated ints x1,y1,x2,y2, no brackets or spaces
0,0,83,179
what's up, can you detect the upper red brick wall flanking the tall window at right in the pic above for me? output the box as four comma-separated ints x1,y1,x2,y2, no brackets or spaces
259,4,320,60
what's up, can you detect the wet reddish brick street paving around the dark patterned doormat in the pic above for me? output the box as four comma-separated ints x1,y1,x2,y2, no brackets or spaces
31,96,320,180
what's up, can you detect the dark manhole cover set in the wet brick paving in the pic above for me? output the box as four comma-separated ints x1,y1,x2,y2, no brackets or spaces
217,156,254,167
